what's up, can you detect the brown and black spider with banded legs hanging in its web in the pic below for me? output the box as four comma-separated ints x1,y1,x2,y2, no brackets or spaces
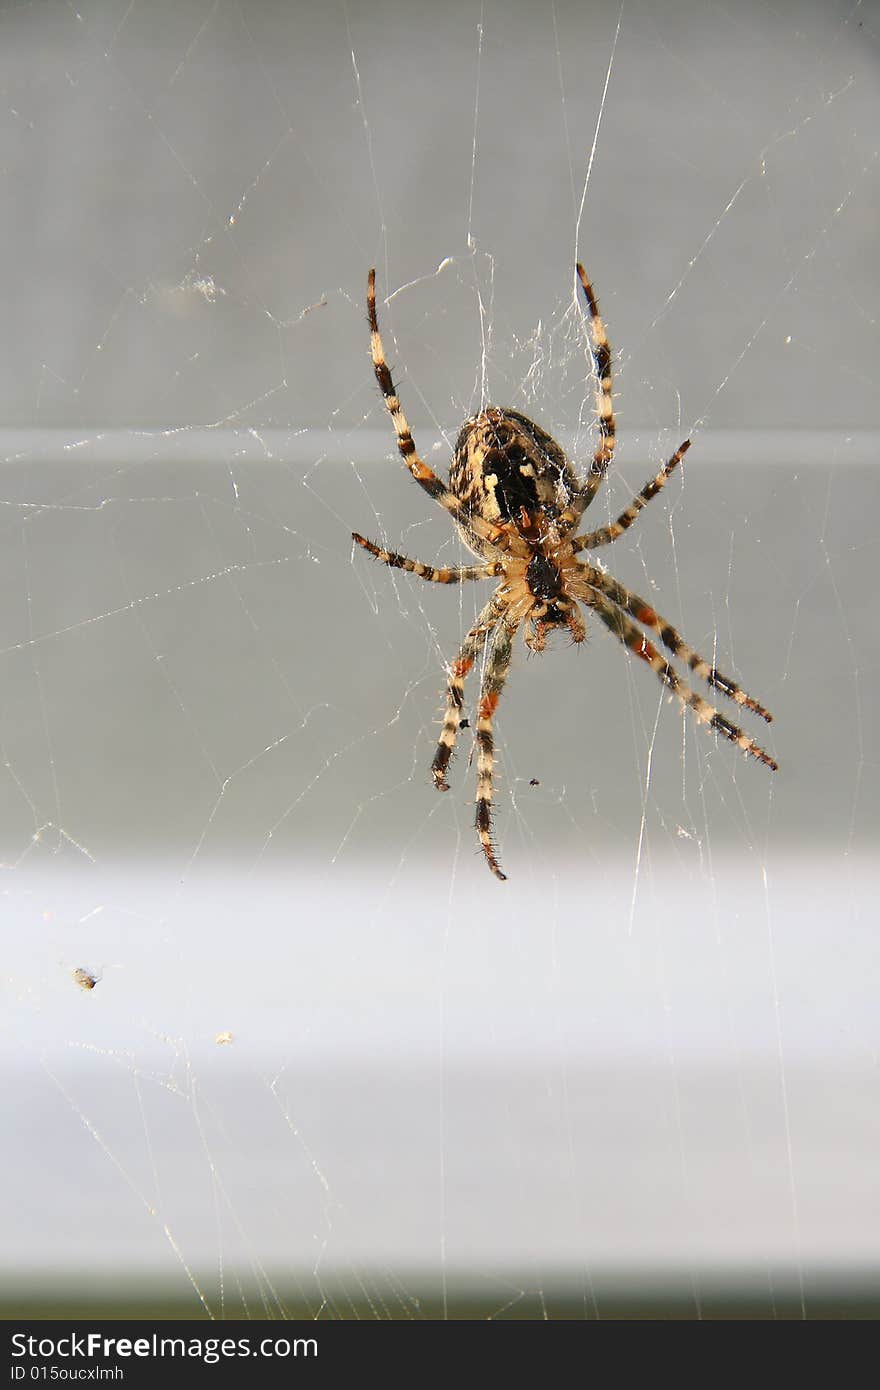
352,265,779,878
